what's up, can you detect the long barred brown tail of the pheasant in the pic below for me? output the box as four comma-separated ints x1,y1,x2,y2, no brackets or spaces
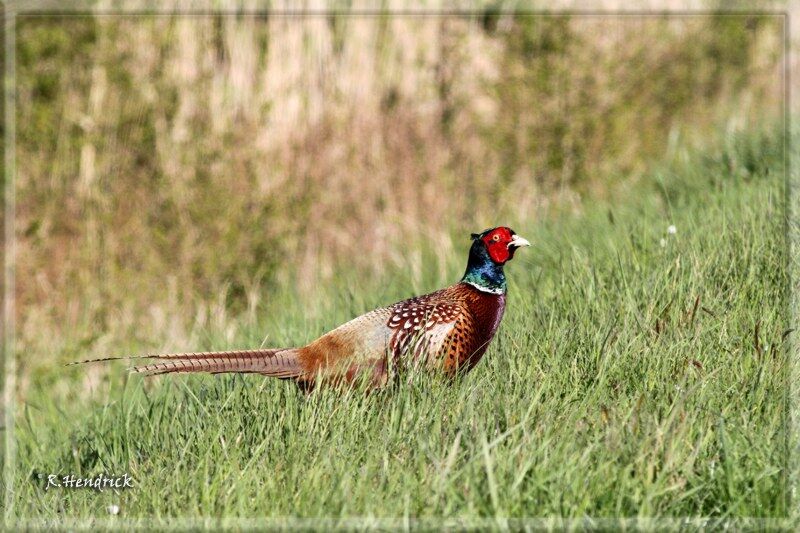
69,349,304,379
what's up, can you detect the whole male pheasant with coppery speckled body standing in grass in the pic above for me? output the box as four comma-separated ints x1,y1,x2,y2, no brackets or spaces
76,227,530,390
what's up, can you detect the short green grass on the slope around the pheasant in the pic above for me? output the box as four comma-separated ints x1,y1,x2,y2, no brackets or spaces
7,129,789,521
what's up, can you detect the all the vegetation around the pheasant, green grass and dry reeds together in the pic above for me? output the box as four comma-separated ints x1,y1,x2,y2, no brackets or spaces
7,9,788,517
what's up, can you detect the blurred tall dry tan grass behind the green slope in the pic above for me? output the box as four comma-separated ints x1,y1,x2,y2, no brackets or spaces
17,10,783,394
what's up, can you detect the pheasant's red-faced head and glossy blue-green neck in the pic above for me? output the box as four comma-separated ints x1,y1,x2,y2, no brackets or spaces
461,226,531,294
